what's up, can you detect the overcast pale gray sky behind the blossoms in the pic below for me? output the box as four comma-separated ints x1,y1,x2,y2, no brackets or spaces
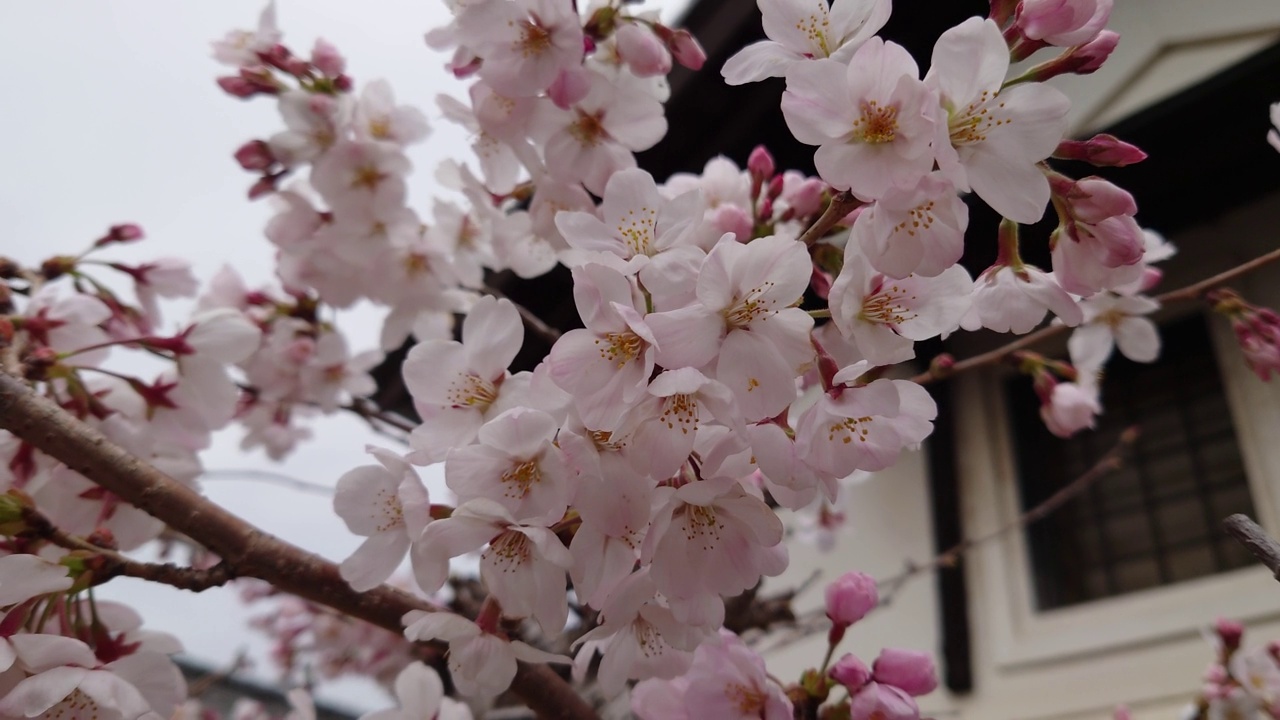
0,0,689,707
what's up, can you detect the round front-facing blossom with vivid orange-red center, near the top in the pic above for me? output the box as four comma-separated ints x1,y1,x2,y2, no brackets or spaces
782,37,936,200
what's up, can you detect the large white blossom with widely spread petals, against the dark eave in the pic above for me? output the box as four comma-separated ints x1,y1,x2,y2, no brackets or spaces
924,18,1070,223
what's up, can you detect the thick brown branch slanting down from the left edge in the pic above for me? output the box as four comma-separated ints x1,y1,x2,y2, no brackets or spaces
0,373,595,720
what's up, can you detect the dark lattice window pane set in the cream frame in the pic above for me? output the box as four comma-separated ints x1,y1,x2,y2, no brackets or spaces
1009,316,1253,610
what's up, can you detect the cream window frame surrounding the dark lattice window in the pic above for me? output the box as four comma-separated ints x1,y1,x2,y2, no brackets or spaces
955,307,1280,669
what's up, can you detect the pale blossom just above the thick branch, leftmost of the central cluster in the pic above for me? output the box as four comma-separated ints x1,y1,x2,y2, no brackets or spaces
333,447,431,592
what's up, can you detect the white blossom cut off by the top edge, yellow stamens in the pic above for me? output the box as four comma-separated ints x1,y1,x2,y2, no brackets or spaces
721,0,891,85
